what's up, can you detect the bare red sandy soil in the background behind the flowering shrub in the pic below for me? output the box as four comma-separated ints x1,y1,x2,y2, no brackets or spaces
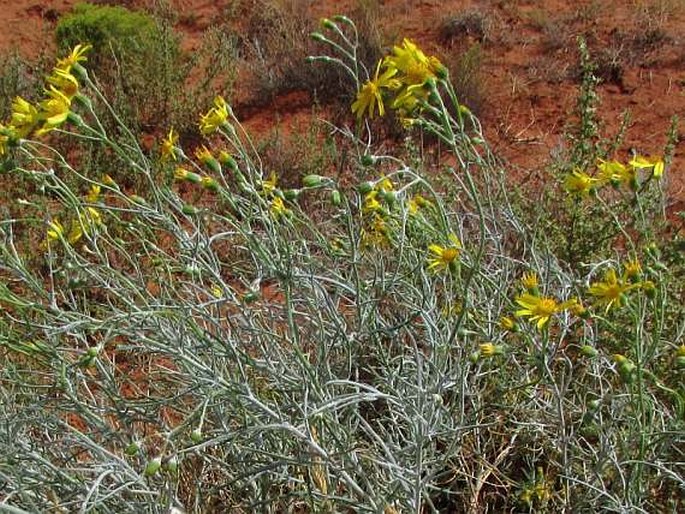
0,0,685,208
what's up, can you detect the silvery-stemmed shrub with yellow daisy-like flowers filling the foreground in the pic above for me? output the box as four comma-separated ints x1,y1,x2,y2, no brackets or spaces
0,16,685,513
